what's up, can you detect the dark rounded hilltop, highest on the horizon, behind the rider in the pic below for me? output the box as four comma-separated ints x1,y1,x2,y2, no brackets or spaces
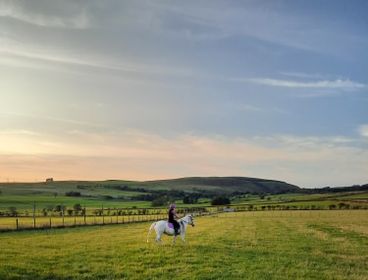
140,177,300,194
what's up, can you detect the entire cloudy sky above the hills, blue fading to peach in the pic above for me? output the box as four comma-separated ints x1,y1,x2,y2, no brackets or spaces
0,0,368,188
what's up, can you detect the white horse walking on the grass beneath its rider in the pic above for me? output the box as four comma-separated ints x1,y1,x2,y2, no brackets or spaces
147,215,194,243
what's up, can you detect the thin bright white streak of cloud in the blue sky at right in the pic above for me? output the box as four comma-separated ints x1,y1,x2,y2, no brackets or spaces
244,78,366,91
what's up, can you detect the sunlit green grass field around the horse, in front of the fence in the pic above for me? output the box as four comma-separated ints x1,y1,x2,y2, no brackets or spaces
0,210,368,279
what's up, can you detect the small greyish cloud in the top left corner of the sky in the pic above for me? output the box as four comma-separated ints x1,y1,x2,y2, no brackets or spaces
0,1,90,29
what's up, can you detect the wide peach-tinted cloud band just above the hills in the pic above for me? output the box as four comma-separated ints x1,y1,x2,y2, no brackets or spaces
0,130,368,186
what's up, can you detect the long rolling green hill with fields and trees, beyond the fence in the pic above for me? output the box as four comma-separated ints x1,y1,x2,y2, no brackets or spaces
0,177,299,211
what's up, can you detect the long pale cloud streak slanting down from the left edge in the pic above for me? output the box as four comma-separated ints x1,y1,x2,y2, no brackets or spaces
0,36,207,79
